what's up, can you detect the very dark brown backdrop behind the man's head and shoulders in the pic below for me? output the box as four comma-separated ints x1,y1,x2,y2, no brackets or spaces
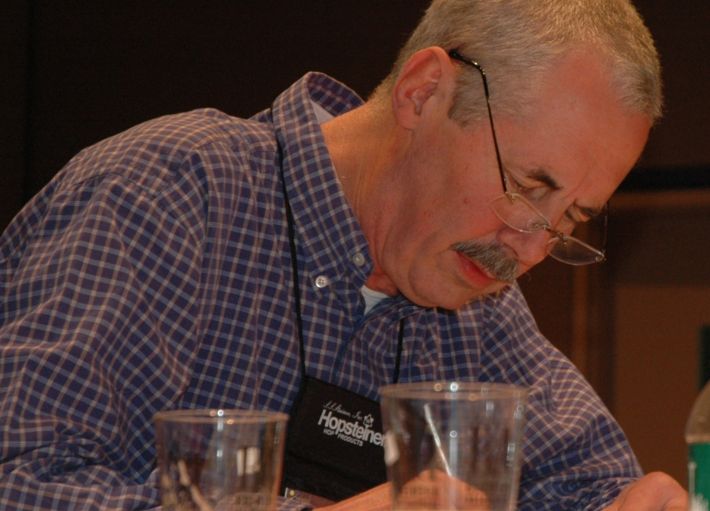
0,0,710,232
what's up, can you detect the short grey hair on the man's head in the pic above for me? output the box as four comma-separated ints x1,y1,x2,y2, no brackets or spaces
374,0,663,125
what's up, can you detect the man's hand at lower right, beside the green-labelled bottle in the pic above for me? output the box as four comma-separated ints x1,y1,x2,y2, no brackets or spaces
604,472,688,511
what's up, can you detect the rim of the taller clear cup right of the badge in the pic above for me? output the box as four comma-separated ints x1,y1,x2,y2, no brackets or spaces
379,380,530,400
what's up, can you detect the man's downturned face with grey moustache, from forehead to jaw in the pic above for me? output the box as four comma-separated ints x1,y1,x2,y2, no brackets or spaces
375,52,650,309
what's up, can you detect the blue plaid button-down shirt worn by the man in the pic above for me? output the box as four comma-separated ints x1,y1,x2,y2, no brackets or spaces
0,73,640,511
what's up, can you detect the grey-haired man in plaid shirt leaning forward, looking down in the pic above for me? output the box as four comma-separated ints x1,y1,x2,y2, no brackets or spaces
0,0,685,511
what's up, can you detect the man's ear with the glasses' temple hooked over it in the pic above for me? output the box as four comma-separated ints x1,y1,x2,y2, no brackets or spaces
392,46,455,129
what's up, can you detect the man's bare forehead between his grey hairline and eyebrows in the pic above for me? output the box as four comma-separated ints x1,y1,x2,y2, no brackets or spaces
496,52,651,208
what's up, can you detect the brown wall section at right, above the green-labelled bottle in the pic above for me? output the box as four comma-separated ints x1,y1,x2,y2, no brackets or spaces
610,191,710,481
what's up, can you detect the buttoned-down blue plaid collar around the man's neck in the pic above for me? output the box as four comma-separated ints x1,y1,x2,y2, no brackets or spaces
272,73,372,289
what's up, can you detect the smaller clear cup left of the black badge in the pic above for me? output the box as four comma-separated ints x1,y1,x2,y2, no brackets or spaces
155,410,288,511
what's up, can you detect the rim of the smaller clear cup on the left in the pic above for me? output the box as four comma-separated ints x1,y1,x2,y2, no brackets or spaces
153,408,288,424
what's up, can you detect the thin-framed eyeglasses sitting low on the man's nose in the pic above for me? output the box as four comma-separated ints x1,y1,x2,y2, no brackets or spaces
449,50,608,266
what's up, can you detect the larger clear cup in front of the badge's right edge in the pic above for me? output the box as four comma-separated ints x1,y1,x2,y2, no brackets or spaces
380,382,527,511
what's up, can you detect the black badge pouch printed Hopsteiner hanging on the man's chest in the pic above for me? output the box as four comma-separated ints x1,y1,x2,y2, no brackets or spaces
284,376,387,501
